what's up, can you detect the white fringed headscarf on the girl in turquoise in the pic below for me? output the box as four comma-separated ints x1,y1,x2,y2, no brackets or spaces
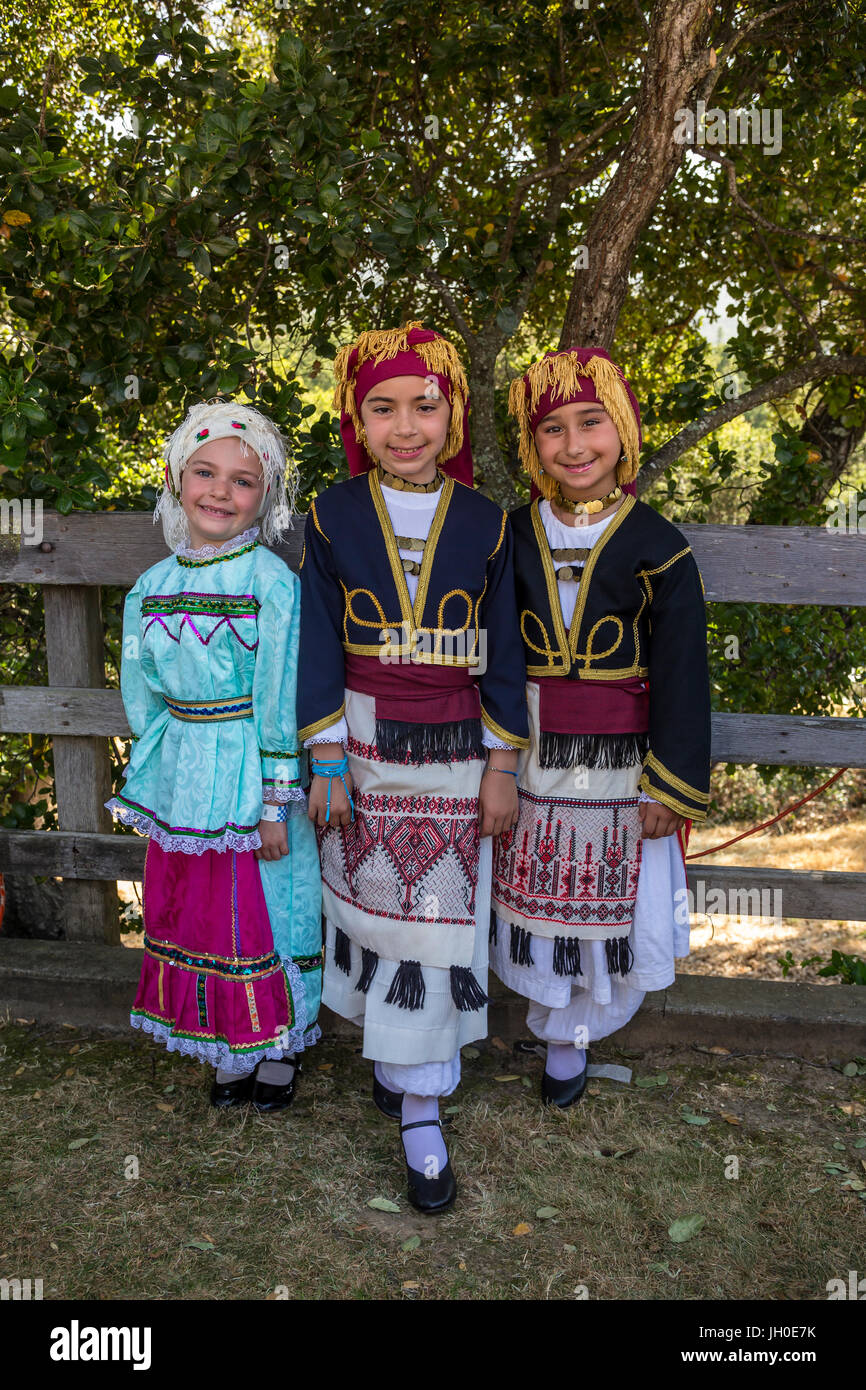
153,400,297,550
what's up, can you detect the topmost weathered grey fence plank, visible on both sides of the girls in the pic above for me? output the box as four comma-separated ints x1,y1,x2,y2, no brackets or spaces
0,512,866,605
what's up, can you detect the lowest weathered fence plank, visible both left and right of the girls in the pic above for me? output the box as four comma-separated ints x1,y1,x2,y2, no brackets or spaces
0,830,866,922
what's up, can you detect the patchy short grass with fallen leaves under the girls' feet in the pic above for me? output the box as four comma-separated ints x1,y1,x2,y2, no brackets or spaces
0,1022,866,1300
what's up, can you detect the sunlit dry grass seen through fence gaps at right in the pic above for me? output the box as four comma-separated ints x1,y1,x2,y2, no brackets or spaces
678,815,866,986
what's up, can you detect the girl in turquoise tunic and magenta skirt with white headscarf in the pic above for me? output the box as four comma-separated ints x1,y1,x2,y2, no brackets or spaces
107,400,321,1111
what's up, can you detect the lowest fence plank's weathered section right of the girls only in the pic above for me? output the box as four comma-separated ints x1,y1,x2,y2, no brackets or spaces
685,858,866,922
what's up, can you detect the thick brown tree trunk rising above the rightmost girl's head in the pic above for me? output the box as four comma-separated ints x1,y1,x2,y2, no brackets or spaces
559,0,713,349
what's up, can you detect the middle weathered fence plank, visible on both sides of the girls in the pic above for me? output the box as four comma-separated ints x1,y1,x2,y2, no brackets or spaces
0,685,866,767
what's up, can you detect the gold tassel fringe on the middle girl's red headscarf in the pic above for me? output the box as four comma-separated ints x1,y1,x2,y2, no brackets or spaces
334,320,468,463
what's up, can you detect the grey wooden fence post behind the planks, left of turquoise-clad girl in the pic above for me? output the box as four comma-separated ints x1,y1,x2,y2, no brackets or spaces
42,584,120,945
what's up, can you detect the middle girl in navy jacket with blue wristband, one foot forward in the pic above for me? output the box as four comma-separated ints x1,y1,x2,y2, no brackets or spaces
297,324,527,1212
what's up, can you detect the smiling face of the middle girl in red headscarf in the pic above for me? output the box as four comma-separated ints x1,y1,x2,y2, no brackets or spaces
361,377,450,482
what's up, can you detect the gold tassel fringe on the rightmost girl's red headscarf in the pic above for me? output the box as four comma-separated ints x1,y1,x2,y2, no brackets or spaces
509,352,639,500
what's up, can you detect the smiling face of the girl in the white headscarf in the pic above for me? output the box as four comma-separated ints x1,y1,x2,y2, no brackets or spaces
181,438,264,549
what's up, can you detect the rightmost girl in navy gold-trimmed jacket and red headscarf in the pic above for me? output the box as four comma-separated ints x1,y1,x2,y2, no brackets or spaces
491,348,710,1108
